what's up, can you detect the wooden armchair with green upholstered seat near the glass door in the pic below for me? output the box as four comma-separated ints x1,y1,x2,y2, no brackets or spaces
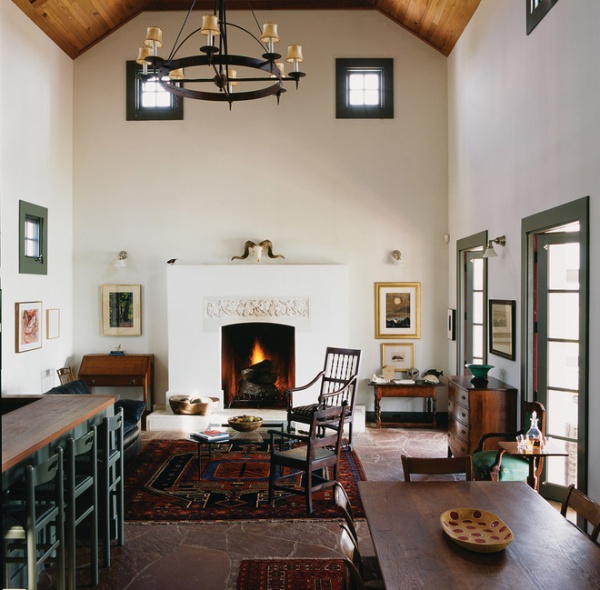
473,402,546,490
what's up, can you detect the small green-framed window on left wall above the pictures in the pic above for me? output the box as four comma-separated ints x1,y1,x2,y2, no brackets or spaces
19,201,48,275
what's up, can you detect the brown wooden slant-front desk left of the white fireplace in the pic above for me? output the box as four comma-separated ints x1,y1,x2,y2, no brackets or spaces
79,354,154,428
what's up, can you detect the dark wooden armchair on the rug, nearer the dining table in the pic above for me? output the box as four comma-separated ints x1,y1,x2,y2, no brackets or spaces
269,403,346,514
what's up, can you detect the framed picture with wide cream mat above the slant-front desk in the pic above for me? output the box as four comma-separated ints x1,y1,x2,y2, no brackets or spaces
101,285,142,336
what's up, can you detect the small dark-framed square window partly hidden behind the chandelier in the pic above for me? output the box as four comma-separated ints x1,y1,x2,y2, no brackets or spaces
127,61,183,121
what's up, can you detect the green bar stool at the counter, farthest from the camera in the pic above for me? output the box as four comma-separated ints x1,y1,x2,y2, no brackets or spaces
98,408,125,567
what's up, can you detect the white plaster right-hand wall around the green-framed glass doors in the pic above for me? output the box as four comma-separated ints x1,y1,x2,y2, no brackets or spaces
448,0,600,497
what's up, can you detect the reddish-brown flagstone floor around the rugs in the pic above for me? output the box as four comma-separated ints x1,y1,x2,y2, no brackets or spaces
39,428,447,590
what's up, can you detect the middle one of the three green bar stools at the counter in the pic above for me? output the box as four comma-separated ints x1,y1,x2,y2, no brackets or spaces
64,426,98,590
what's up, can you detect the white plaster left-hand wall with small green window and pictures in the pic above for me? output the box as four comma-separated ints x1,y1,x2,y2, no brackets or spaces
0,2,73,394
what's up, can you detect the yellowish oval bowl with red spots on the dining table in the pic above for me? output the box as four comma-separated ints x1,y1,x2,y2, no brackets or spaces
440,508,514,553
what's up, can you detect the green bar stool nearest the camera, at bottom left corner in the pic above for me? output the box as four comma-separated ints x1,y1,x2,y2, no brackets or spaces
2,448,65,590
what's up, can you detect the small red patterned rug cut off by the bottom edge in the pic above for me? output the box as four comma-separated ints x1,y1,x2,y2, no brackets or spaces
237,559,346,590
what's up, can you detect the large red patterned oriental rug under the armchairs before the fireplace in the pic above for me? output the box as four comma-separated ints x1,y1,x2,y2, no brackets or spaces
125,440,366,521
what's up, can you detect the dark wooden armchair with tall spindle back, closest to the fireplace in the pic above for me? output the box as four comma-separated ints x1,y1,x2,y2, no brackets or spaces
285,347,361,448
